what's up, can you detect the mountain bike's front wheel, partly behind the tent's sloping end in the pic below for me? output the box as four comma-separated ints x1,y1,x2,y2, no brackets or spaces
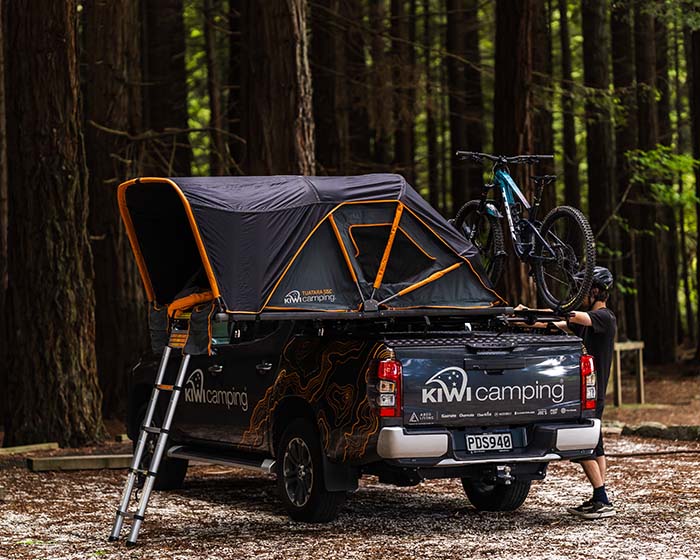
454,200,506,285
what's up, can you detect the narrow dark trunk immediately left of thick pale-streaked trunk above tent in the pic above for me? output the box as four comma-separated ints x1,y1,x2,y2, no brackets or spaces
226,0,246,175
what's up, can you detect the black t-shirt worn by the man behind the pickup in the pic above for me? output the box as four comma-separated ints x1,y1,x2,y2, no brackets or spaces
570,307,617,407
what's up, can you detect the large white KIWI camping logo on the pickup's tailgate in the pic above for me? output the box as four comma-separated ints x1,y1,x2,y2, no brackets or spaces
421,366,564,404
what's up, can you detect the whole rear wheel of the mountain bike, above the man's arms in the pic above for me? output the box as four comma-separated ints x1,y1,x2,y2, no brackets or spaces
533,206,596,311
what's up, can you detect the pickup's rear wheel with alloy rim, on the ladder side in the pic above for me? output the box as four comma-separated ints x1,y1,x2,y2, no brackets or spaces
276,419,346,523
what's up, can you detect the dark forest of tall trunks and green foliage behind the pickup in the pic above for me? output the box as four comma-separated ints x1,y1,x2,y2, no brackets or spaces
0,0,700,446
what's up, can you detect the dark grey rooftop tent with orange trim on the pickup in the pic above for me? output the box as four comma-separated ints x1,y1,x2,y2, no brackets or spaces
119,174,505,314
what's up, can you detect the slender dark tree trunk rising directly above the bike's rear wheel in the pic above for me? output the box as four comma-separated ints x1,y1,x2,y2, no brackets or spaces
559,0,581,208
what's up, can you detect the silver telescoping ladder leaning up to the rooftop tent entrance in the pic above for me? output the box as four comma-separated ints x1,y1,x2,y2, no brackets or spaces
109,330,190,546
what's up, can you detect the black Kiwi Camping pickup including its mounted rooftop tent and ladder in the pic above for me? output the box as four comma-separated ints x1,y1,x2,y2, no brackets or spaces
117,174,600,528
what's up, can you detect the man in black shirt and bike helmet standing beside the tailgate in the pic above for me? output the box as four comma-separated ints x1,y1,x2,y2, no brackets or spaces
567,266,617,519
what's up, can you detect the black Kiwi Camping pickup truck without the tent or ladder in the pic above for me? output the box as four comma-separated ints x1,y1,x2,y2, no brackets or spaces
129,317,600,521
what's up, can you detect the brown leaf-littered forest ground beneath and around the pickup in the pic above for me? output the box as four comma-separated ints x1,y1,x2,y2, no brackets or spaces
0,368,700,560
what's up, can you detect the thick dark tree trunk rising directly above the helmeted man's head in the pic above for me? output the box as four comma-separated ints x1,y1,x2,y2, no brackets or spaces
581,0,615,244
